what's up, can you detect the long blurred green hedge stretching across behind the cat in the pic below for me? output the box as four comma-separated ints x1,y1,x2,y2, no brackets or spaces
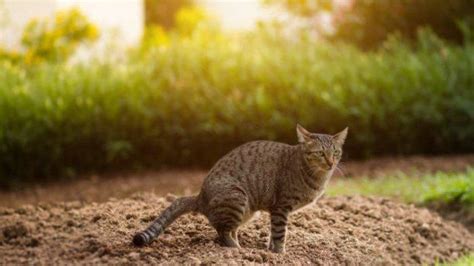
0,28,474,184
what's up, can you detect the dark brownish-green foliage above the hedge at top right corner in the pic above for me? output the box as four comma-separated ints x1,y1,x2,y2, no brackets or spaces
264,0,474,48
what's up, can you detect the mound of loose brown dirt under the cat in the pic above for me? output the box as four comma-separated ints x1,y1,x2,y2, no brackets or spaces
0,194,474,265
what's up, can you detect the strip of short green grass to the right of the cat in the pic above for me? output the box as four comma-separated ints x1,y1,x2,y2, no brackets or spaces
327,168,474,207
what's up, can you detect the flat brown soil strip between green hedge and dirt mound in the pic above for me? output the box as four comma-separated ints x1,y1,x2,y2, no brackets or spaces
0,155,474,207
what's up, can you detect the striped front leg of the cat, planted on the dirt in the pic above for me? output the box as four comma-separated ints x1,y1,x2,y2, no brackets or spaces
268,208,289,253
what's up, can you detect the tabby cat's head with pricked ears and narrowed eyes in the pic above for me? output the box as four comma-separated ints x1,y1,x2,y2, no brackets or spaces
296,125,348,171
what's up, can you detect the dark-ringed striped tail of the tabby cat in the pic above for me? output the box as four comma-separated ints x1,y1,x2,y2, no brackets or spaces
133,196,198,247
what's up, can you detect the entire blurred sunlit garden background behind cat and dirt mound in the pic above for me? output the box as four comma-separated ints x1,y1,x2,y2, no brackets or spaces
0,0,474,234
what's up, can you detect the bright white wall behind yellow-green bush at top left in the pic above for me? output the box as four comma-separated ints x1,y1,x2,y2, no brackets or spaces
0,0,145,48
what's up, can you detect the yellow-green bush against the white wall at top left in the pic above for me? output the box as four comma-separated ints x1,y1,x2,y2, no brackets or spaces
0,9,98,65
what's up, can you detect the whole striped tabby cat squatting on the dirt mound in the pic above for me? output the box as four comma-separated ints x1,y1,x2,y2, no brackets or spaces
132,125,348,253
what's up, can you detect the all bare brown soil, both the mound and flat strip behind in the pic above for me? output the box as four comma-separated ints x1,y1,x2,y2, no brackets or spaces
0,156,474,265
